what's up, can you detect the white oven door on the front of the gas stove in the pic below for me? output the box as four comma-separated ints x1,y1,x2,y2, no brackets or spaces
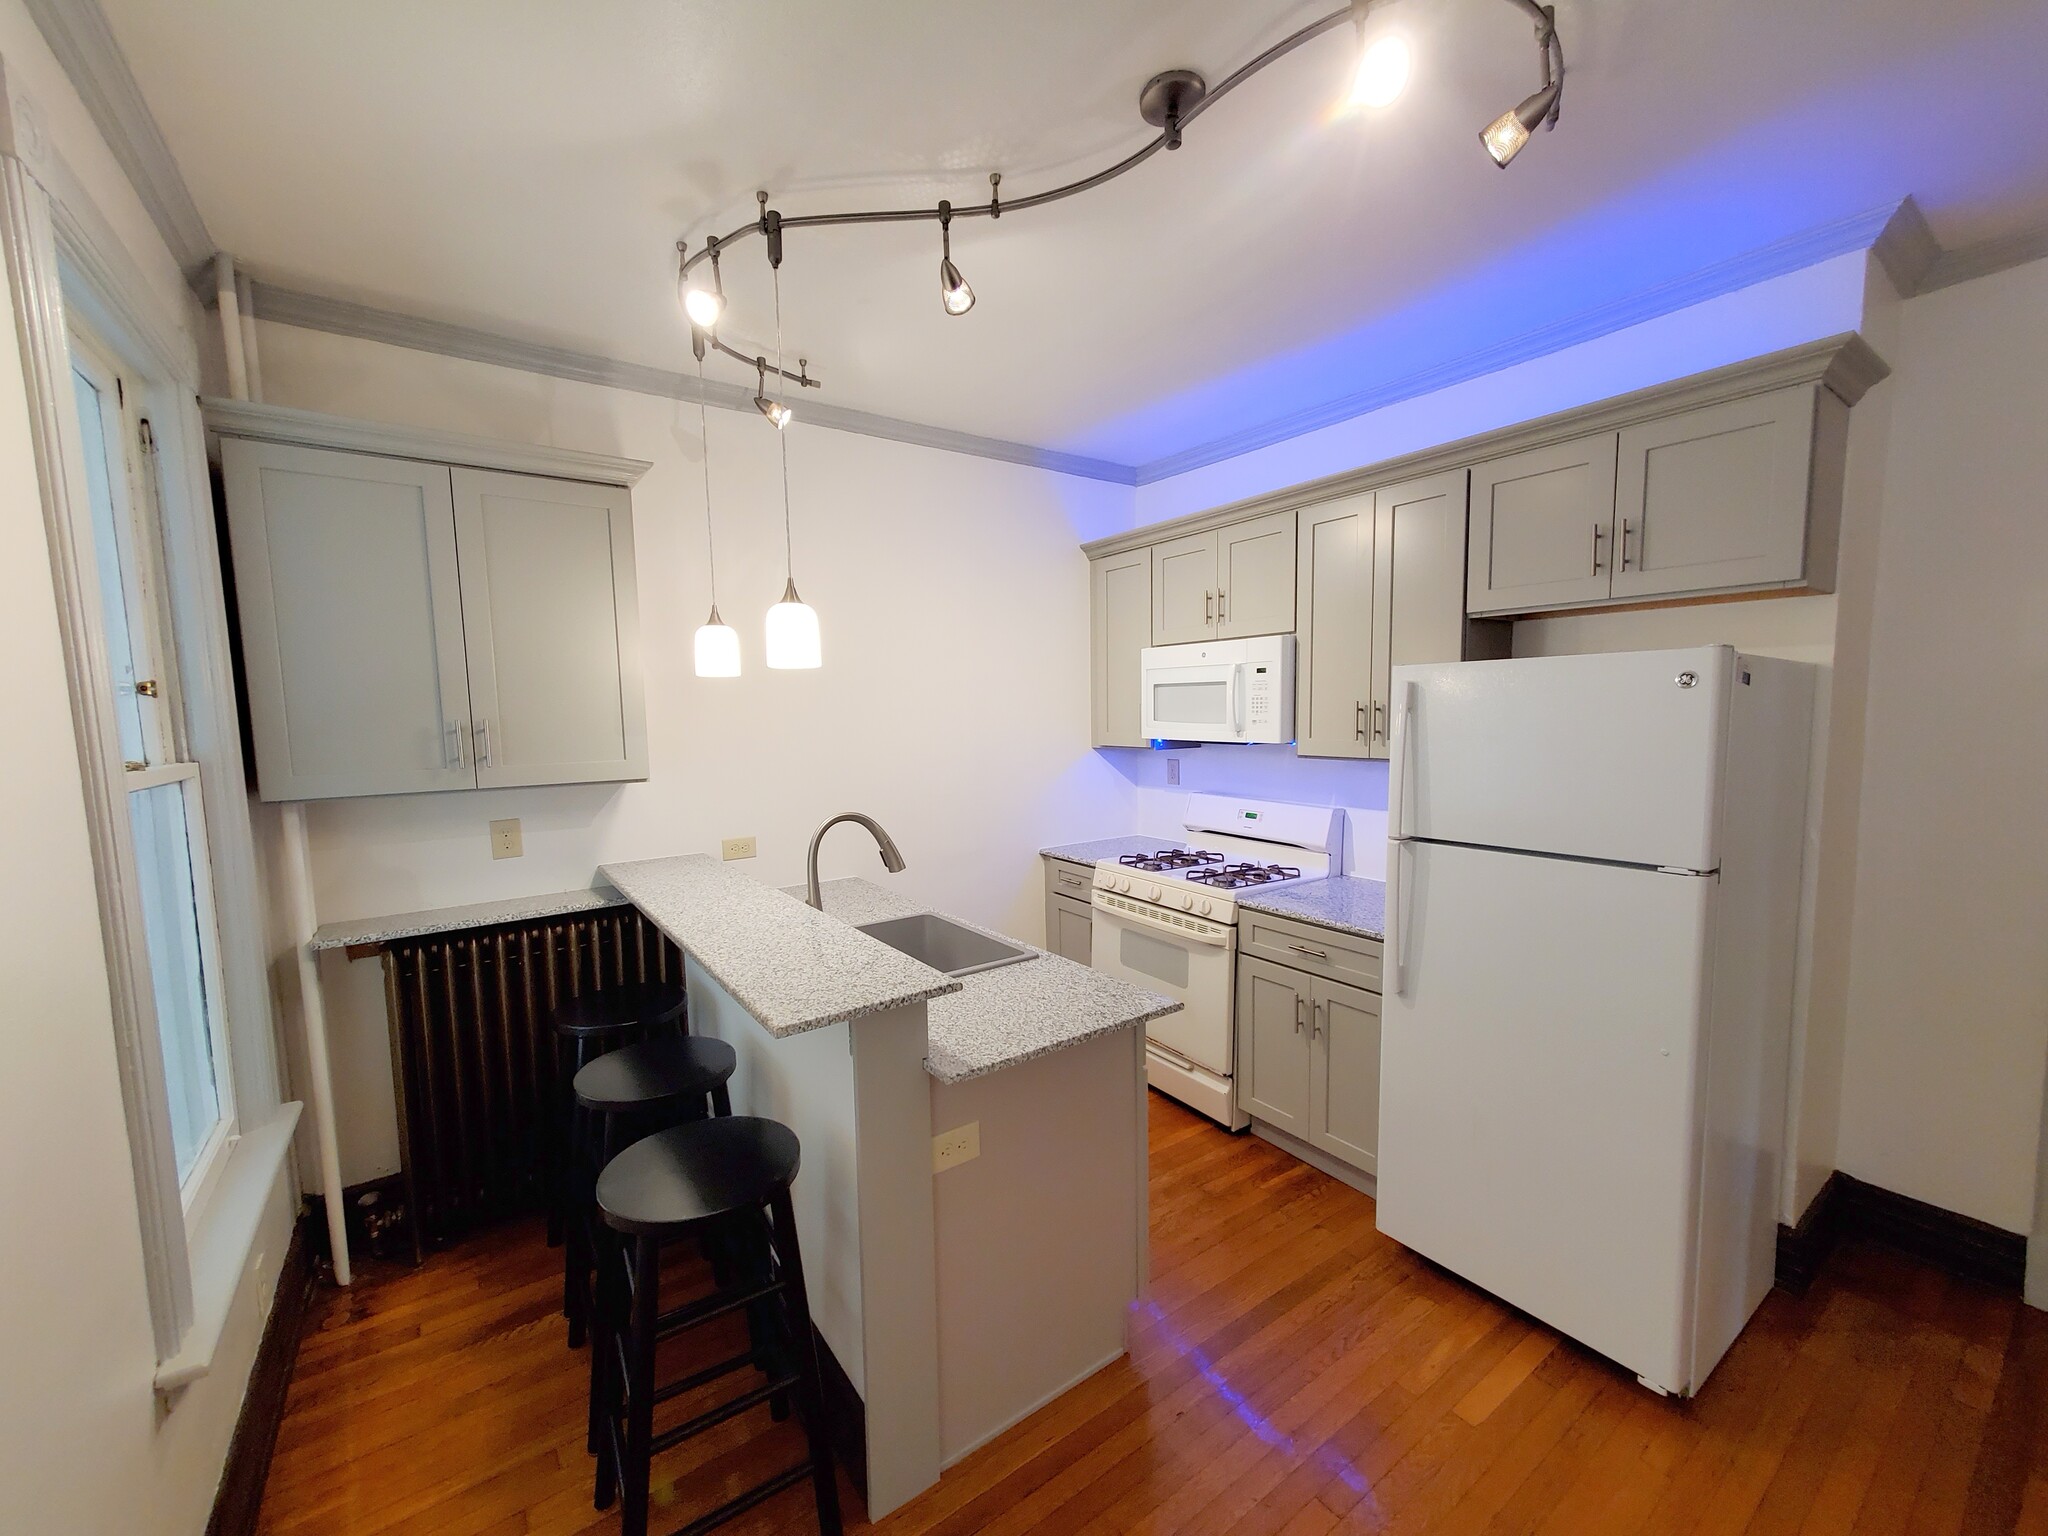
1090,891,1237,1077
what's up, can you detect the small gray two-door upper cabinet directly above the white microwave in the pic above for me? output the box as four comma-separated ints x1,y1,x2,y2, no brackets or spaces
1151,512,1294,645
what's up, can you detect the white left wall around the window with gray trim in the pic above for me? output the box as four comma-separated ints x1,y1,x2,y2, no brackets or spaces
0,0,293,1536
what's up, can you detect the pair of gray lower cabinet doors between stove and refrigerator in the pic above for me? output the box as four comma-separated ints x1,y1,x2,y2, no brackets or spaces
1237,954,1380,1174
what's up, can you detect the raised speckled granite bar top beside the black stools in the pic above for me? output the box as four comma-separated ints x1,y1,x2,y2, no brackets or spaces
598,854,961,1038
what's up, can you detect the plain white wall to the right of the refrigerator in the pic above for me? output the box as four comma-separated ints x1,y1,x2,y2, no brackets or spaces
1841,262,2048,1233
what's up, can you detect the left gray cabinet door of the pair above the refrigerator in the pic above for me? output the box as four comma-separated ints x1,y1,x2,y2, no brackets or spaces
1464,432,1616,612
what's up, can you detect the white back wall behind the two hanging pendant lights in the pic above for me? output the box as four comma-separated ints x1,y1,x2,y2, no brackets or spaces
258,324,1133,1182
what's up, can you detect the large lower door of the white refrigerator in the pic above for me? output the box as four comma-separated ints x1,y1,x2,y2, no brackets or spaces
1378,844,1716,1393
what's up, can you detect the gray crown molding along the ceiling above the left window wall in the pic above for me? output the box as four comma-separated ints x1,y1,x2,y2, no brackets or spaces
23,0,215,276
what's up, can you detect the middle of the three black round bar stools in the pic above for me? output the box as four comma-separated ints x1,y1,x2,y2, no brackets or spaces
561,1034,739,1359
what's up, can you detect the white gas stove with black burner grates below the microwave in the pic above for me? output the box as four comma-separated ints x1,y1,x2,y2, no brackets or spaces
1092,795,1343,1130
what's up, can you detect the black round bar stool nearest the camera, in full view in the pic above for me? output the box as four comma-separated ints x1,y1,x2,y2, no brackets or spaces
596,1116,840,1536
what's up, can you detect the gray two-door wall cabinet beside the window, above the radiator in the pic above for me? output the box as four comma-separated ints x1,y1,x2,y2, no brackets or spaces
209,403,647,801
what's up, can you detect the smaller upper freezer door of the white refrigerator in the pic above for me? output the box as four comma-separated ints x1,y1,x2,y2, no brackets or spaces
1386,645,1735,870
